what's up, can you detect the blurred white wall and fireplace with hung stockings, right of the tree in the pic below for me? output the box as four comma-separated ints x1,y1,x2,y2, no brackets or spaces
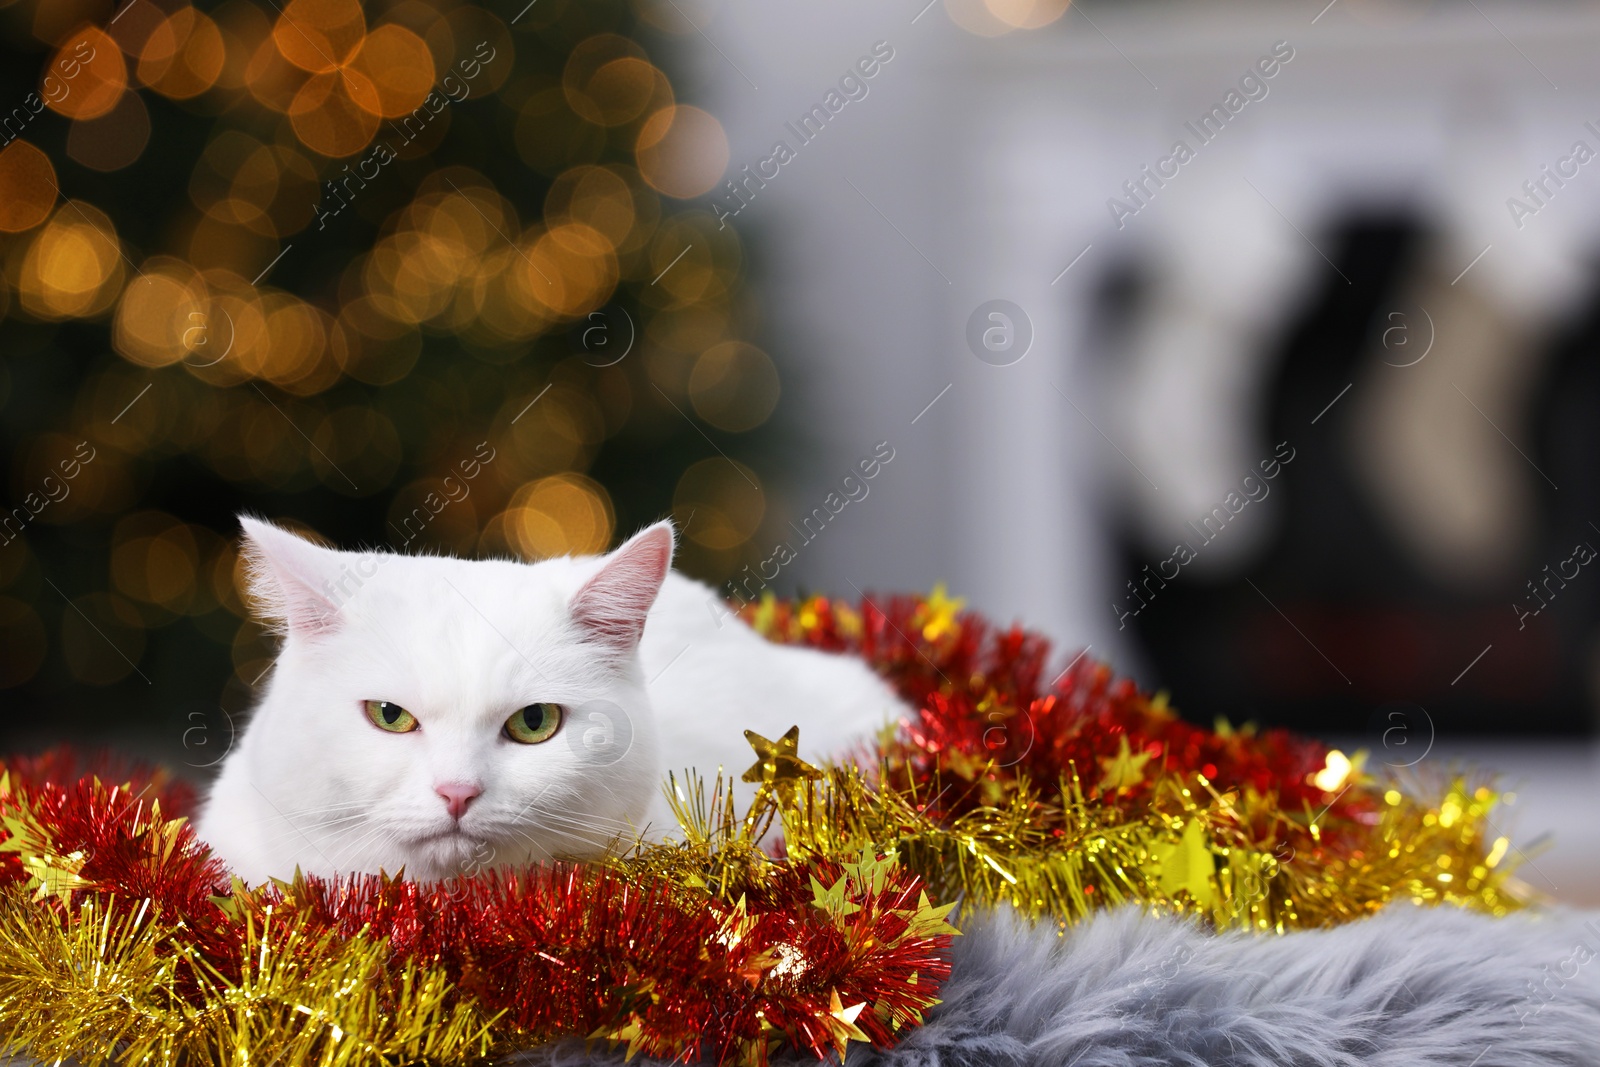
699,2,1600,734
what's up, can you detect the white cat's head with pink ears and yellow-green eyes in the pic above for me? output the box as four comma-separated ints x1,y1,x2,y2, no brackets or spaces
219,517,674,878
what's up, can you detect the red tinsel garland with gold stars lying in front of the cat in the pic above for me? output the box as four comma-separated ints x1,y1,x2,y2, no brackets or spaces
0,764,952,1062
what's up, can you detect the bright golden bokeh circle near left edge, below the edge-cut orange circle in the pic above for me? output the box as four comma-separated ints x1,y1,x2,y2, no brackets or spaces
18,200,123,318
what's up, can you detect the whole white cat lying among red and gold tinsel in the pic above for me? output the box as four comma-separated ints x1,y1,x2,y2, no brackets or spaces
197,517,904,883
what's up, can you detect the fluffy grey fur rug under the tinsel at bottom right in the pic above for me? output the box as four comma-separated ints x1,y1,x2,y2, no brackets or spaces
515,904,1600,1067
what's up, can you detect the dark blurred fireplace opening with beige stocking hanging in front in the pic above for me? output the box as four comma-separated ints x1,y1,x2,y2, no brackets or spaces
1123,214,1600,739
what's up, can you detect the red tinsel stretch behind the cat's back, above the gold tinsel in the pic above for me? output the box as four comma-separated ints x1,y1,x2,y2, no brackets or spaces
742,597,1344,816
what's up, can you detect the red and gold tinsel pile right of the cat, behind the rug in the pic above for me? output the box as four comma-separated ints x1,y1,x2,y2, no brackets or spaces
729,587,1531,933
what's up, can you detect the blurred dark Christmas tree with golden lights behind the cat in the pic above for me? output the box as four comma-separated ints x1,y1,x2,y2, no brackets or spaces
0,0,779,765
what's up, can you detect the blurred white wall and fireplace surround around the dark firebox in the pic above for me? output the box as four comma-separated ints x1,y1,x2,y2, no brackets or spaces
686,0,1600,665
